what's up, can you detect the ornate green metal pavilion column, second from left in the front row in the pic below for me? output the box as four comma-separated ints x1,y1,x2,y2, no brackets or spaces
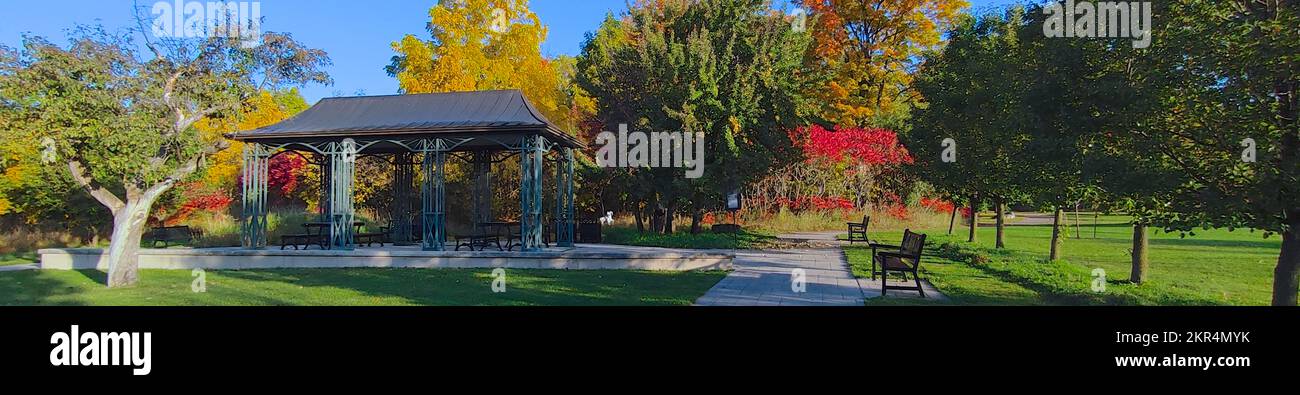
329,139,356,251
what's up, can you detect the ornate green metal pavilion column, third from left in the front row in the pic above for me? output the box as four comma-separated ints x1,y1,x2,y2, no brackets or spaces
420,139,447,251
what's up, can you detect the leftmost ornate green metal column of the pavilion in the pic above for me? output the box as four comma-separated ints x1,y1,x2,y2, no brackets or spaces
239,143,270,249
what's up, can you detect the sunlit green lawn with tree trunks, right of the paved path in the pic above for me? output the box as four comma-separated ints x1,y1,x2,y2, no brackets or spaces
846,216,1282,305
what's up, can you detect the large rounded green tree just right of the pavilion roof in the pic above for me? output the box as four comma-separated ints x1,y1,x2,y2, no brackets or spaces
577,0,816,231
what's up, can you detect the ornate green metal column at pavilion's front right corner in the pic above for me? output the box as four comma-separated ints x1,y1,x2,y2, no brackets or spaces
519,135,546,252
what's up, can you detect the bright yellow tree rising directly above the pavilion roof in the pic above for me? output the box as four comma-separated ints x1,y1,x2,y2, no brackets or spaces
387,0,577,130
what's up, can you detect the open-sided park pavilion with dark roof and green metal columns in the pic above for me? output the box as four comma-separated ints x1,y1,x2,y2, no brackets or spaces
228,90,584,252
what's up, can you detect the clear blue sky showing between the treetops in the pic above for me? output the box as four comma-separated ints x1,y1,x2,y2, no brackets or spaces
0,0,1024,103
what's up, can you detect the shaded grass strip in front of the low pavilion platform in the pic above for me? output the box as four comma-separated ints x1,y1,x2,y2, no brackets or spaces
0,269,725,305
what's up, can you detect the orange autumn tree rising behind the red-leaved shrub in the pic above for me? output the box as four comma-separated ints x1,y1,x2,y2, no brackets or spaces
797,0,970,126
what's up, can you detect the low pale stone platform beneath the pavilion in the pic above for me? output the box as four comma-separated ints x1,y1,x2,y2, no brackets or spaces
39,244,736,272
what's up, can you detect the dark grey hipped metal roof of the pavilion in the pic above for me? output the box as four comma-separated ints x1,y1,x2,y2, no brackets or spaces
228,90,584,148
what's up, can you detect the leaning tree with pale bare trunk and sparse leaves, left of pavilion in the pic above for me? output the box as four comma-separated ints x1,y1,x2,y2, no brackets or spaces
0,23,330,287
